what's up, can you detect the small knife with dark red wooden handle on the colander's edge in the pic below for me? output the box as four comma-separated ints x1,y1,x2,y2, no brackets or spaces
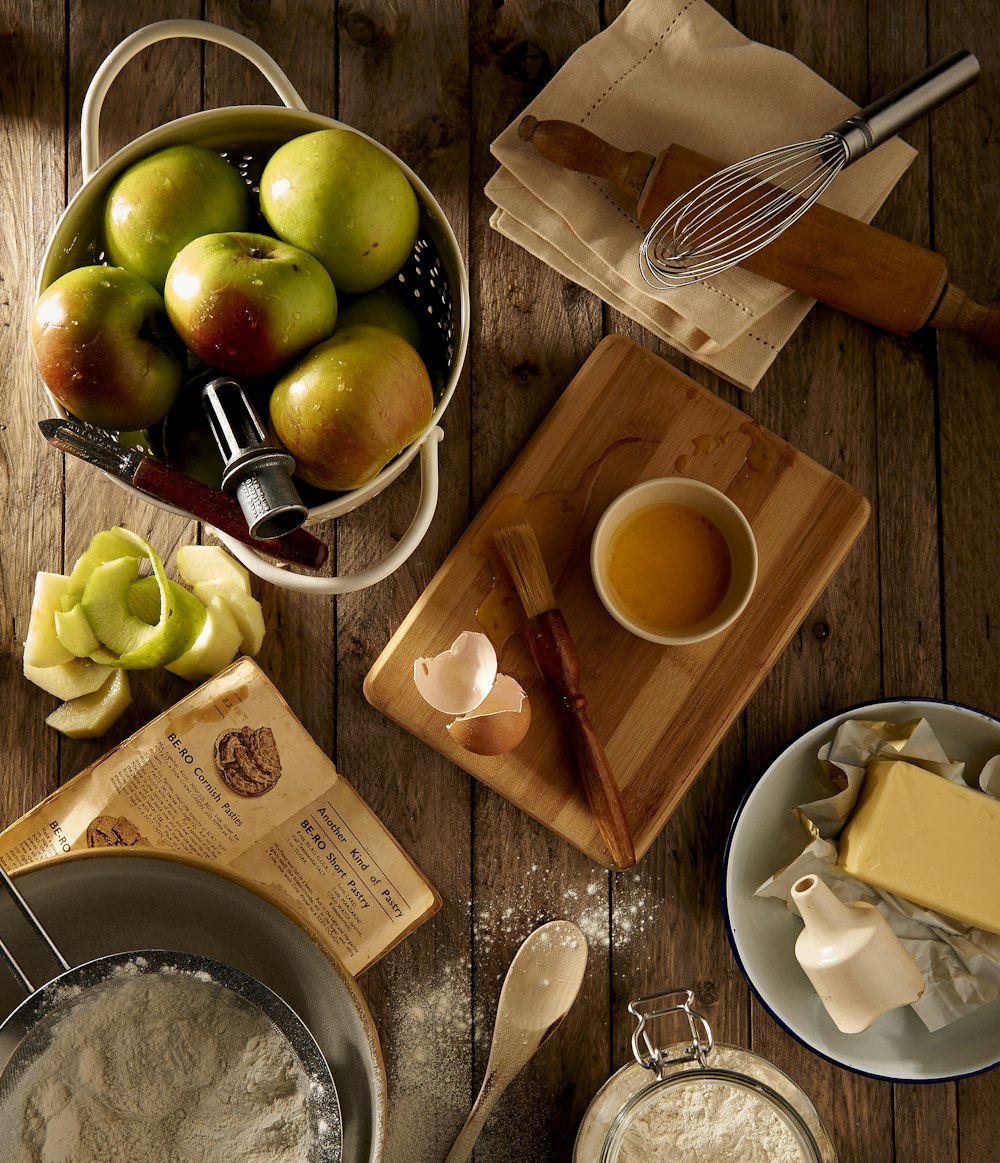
38,419,329,570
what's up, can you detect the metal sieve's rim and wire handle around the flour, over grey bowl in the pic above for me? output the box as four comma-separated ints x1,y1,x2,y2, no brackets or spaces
0,866,343,1163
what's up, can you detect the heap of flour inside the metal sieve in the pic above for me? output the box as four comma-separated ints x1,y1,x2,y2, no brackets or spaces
0,971,312,1163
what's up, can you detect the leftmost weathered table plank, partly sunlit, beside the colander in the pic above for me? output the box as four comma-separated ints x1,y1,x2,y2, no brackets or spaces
0,3,66,826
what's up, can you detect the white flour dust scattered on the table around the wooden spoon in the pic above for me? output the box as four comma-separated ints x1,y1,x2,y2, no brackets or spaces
383,865,658,1163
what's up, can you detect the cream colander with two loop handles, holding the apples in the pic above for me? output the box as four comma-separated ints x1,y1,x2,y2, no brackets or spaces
31,20,470,593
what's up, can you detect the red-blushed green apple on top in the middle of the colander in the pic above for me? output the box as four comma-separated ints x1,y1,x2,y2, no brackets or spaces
164,231,337,376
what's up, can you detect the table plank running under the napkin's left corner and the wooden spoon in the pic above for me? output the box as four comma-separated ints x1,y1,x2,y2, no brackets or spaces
470,0,615,1160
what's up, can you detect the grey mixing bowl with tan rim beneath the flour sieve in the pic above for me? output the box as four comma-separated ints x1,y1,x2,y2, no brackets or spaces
0,849,385,1163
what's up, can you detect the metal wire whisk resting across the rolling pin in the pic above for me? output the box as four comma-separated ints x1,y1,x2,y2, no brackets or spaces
640,51,979,287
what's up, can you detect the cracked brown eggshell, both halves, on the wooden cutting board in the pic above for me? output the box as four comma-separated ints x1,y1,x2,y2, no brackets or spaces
413,630,531,755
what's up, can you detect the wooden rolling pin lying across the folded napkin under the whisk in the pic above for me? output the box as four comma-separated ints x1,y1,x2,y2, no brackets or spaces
519,116,1000,352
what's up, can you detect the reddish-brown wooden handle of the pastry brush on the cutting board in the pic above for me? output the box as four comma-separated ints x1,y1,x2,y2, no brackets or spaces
528,609,636,871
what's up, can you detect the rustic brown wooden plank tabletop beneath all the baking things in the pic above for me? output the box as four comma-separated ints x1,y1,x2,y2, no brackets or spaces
0,0,1000,1163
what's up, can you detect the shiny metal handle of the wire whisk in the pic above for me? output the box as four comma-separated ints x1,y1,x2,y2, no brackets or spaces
830,49,979,165
